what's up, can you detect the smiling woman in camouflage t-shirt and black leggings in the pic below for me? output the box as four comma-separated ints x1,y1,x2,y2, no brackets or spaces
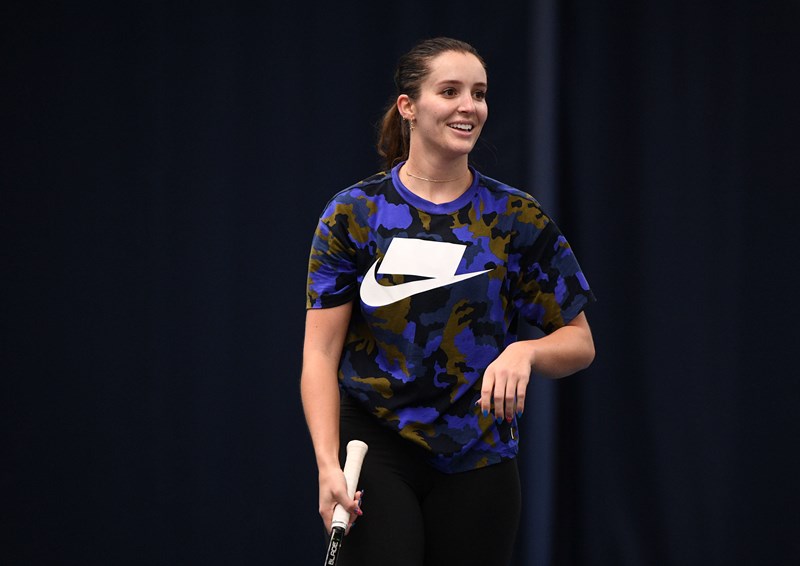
301,38,594,566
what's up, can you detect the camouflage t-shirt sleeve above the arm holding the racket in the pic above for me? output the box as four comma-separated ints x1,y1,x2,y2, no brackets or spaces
306,198,358,309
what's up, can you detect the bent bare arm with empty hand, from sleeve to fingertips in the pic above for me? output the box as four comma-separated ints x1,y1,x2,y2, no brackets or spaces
480,313,594,422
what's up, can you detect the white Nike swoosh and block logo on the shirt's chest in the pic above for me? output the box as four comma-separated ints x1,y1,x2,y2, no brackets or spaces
361,238,491,307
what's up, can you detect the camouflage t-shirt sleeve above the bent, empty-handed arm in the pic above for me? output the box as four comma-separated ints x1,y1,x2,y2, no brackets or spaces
513,216,595,334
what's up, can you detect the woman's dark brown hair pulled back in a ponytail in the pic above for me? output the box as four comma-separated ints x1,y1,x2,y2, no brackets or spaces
378,37,486,169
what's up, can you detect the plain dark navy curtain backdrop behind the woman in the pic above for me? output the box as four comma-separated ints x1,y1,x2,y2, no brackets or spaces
0,0,800,566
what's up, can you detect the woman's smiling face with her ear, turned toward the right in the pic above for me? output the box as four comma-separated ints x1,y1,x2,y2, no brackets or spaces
398,51,489,159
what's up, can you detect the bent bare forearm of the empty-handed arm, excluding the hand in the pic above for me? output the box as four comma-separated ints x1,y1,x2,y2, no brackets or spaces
509,314,595,379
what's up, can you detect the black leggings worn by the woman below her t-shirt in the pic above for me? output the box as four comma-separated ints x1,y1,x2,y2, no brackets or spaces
339,395,521,566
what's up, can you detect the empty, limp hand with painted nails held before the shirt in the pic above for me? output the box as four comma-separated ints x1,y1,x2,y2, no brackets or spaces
479,342,533,422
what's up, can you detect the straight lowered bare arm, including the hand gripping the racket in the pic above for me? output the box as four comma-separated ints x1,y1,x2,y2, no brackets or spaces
300,303,360,529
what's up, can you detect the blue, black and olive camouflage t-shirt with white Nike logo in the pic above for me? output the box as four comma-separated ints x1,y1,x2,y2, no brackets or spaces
306,164,594,473
